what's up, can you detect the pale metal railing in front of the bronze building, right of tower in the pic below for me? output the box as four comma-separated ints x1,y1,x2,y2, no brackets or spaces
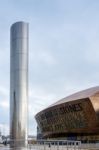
29,140,81,150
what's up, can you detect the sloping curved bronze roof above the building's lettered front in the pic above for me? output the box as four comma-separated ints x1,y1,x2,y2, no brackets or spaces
49,86,99,107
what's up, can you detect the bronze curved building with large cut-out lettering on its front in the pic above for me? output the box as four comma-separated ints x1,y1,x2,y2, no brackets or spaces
35,87,99,142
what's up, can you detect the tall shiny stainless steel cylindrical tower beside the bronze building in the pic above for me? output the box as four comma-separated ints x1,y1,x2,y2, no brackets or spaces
10,22,28,145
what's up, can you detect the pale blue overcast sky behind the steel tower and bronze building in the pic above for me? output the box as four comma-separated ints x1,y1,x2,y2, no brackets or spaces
0,0,99,135
